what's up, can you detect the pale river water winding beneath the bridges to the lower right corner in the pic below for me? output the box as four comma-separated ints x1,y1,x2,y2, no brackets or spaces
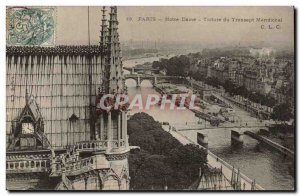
123,57,294,190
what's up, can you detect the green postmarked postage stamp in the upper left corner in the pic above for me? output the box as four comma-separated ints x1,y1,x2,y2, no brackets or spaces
7,7,55,46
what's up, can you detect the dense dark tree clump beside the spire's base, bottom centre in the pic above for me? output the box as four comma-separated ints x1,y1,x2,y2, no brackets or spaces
128,113,208,190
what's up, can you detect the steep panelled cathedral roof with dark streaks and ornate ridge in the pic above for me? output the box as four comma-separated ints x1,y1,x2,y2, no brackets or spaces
6,46,103,147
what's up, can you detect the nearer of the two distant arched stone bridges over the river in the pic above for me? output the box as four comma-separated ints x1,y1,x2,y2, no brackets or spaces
124,74,184,87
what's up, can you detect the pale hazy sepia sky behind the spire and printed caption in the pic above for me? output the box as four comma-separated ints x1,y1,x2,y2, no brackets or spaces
8,6,294,45
